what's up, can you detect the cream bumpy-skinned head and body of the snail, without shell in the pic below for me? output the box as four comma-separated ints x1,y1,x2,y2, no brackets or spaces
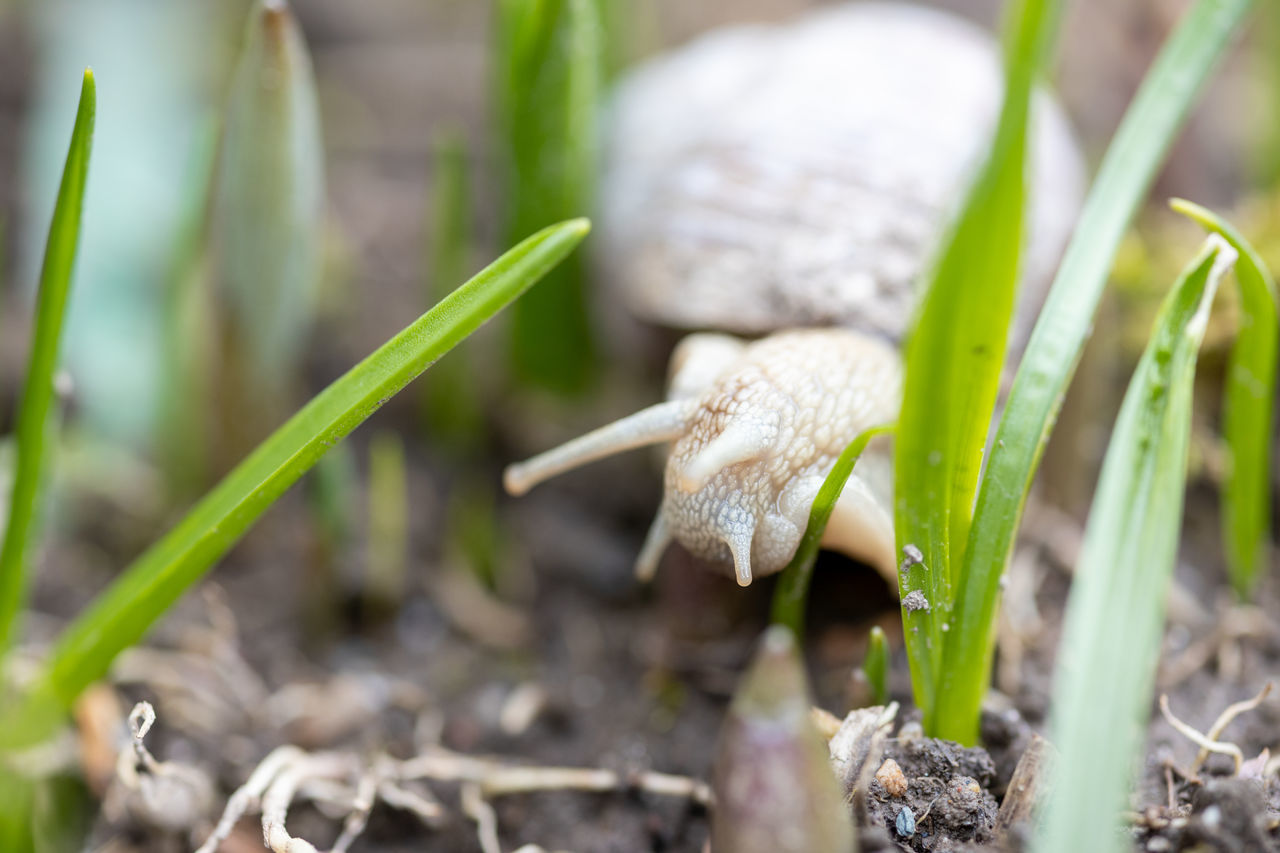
506,329,902,587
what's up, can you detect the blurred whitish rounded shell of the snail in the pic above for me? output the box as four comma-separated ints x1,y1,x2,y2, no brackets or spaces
599,3,1084,341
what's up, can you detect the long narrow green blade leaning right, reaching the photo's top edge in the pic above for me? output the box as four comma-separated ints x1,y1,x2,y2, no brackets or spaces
936,0,1251,743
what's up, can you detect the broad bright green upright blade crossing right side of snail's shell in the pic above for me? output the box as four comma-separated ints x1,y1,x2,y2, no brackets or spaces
893,0,1059,733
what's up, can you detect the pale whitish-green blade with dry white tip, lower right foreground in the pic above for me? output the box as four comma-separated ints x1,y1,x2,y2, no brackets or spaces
1033,236,1236,853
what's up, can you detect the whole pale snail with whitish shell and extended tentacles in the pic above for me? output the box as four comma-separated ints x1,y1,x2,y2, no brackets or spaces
504,3,1084,588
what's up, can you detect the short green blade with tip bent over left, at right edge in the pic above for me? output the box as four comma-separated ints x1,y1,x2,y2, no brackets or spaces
1172,199,1280,599
